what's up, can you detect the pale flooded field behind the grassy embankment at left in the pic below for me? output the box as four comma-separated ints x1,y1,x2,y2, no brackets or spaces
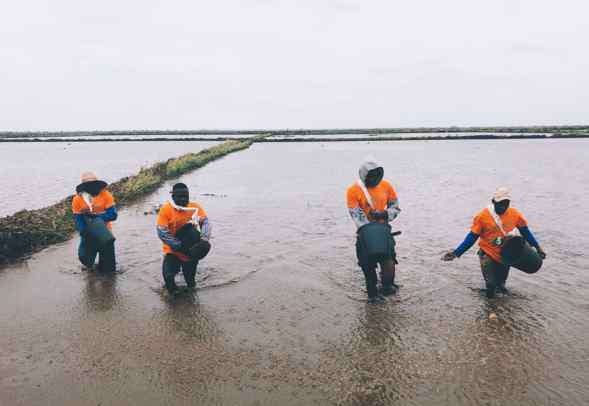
0,141,218,217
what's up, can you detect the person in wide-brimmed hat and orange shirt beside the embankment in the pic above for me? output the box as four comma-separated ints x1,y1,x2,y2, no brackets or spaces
72,172,117,272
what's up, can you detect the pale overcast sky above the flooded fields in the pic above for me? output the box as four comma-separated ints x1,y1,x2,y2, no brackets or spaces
0,0,589,130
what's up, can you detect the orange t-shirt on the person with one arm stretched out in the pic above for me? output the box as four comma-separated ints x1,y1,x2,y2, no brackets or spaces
470,207,528,263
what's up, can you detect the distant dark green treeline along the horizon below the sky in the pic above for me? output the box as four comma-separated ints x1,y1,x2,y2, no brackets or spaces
0,125,589,139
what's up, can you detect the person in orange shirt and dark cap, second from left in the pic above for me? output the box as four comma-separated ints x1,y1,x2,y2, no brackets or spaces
157,183,211,294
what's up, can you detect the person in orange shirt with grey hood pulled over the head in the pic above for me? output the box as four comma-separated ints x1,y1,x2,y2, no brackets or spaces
346,158,401,303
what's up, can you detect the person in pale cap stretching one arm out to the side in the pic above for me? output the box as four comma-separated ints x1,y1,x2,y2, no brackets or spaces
442,187,546,298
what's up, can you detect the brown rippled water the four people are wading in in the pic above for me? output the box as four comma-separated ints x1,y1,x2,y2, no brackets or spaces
0,140,589,405
